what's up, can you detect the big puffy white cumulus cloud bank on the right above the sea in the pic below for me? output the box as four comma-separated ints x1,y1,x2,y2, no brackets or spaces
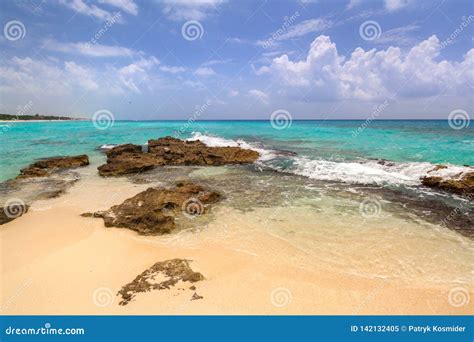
258,35,474,100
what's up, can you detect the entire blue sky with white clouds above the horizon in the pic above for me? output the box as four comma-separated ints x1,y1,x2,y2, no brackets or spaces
0,0,474,120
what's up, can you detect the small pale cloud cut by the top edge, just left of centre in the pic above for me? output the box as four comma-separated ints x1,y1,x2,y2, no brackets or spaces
160,0,226,21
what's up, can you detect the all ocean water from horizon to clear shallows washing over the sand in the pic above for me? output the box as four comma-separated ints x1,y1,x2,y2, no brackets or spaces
0,121,474,286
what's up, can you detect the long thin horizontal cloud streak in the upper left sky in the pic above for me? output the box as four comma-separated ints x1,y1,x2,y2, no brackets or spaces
43,39,139,57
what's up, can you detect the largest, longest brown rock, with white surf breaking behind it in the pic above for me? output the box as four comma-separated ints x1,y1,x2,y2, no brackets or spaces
98,137,260,176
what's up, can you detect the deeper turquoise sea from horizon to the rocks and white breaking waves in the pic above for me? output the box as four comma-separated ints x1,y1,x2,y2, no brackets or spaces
0,120,474,183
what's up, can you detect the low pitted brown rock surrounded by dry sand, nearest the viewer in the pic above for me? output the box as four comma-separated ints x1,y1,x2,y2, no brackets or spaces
117,259,204,305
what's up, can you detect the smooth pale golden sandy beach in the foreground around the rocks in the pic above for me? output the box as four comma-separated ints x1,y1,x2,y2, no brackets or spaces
0,160,474,315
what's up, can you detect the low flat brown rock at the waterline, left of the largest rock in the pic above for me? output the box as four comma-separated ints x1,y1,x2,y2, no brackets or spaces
17,154,89,178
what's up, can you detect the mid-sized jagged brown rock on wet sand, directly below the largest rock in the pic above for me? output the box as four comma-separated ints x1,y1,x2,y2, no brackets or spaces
82,182,222,235
